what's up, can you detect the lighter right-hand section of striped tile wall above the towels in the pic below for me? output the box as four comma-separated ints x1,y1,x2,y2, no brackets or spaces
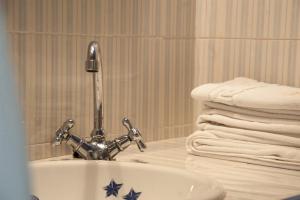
194,0,300,87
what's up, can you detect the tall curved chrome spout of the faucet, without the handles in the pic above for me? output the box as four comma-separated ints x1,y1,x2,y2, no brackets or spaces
85,41,104,137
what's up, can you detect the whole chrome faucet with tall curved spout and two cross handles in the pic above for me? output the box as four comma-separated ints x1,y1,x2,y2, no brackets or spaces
54,41,146,160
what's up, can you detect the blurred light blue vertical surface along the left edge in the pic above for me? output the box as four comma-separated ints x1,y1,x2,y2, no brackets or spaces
0,7,29,200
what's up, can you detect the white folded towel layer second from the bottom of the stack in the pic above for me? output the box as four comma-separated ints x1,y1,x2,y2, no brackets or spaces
198,123,300,148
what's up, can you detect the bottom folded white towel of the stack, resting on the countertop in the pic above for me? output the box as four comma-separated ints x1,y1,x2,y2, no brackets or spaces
186,131,300,170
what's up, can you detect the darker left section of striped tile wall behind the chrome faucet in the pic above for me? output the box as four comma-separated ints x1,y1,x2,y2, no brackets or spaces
6,0,196,160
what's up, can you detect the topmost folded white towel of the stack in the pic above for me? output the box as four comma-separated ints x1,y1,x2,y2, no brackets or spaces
192,78,300,112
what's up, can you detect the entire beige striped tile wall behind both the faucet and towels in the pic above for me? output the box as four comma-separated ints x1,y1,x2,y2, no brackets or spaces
7,0,300,159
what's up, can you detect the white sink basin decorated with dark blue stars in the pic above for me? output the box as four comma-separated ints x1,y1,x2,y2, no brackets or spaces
30,160,225,200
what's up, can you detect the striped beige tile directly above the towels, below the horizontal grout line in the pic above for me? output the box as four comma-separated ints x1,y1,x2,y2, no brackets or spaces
194,39,300,86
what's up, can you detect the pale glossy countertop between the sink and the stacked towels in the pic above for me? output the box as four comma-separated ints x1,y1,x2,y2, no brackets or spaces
47,138,300,200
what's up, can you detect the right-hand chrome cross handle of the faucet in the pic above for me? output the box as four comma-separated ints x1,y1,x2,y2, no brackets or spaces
122,117,147,152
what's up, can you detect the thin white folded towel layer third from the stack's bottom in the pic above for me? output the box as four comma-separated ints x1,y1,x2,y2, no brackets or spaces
197,114,300,138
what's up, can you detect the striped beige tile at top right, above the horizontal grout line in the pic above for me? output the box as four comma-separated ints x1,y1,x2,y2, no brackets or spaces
195,0,300,39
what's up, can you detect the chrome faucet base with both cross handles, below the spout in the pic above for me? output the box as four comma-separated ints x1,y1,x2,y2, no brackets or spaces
54,118,146,160
